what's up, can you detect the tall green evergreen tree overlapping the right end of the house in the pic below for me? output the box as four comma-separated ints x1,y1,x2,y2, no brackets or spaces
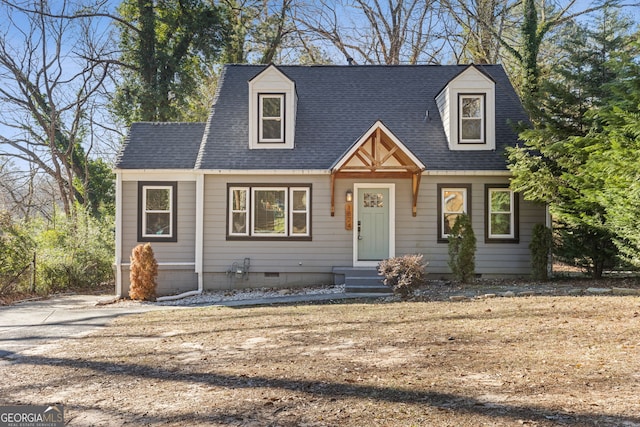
509,9,632,277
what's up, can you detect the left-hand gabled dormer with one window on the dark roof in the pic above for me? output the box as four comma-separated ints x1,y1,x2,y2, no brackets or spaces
249,65,298,150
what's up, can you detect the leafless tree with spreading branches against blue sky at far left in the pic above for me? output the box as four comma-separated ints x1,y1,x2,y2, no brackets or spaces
0,0,110,215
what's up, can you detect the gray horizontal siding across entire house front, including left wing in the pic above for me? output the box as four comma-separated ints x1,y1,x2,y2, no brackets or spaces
114,175,545,290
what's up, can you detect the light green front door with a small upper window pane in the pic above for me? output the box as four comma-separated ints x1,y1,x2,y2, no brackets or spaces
356,188,390,261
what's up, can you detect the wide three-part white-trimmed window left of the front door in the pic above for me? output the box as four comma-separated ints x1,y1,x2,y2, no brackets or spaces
228,185,311,240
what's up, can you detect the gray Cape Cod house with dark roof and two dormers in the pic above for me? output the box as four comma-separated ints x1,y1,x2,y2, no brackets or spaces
115,65,546,295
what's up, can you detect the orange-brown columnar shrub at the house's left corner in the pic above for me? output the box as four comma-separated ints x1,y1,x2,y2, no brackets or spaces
129,243,158,301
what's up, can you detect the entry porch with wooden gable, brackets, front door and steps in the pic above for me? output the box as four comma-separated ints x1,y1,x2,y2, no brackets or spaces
331,121,425,292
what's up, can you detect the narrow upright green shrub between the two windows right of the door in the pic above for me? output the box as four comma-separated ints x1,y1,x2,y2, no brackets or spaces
449,214,476,283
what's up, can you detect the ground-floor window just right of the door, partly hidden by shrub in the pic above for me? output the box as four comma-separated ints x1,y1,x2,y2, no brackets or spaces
438,184,471,242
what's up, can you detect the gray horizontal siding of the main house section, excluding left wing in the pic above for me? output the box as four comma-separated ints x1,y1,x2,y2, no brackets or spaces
204,175,545,276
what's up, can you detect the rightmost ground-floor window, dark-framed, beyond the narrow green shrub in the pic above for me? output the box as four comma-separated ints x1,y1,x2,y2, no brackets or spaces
485,184,519,242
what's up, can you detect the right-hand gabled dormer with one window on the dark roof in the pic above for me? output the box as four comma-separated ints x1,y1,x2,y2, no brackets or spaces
436,65,496,151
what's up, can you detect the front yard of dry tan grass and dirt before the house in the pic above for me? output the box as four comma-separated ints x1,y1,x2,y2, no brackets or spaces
0,296,640,427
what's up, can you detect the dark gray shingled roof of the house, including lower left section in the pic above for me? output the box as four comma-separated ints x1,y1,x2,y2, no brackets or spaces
116,65,527,170
